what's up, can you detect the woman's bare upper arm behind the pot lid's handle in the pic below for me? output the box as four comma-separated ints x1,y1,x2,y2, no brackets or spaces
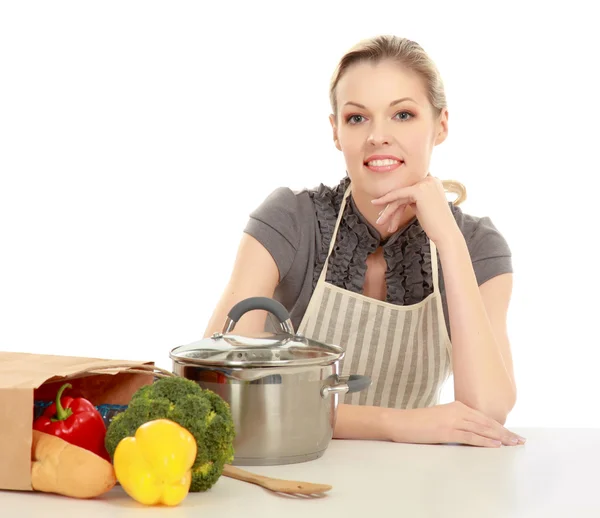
204,233,279,338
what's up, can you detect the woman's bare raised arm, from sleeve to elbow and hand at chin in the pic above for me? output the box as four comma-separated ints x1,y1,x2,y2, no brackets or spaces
371,179,516,423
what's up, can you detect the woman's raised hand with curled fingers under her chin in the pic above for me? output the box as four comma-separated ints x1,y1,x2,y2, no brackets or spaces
371,175,460,248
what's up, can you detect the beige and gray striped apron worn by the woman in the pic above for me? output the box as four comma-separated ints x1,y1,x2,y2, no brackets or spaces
298,187,452,408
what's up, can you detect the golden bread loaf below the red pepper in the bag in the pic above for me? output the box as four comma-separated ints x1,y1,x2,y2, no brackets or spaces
31,430,117,498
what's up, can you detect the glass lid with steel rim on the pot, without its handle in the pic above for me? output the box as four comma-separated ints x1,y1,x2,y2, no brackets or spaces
170,332,344,368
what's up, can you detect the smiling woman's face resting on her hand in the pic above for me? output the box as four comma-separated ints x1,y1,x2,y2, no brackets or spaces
330,61,448,198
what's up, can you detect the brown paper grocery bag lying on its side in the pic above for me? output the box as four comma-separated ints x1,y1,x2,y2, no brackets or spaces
0,352,172,491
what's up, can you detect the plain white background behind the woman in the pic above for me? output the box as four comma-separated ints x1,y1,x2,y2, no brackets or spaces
0,1,600,427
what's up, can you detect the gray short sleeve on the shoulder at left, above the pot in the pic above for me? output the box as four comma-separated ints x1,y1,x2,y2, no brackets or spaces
244,187,301,282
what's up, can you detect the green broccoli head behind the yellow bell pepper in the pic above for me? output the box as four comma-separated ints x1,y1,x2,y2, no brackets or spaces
105,376,235,492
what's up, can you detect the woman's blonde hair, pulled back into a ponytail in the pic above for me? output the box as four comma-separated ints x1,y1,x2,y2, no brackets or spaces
329,35,467,205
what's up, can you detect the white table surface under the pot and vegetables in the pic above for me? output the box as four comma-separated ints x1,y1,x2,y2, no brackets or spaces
0,428,600,518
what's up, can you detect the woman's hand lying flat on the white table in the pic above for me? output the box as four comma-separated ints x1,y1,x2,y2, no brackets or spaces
386,401,525,448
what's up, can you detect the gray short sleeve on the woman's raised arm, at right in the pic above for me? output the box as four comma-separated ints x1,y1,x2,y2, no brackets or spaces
452,206,513,286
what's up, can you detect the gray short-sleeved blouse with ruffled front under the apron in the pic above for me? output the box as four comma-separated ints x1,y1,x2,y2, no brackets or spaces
245,177,512,342
